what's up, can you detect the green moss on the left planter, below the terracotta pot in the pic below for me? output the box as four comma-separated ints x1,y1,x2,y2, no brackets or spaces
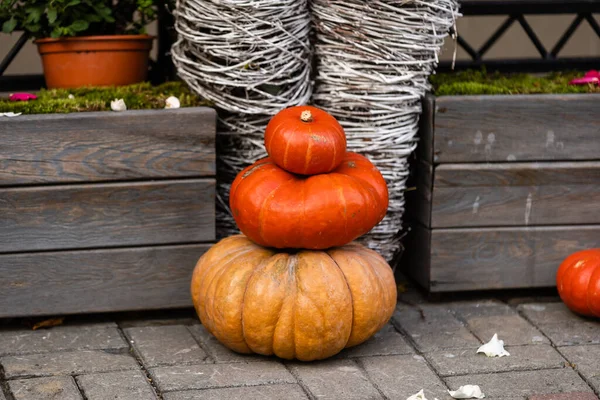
0,82,212,114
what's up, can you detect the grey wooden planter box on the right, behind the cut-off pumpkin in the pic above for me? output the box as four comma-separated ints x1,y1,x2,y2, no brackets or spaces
401,94,600,292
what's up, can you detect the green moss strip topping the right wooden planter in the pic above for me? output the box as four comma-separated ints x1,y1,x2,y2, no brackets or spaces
430,70,600,96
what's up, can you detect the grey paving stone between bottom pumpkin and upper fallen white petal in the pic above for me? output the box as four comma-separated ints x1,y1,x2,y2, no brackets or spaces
392,304,481,352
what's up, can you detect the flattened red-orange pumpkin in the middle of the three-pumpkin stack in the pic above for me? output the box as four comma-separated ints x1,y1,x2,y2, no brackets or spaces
229,152,388,249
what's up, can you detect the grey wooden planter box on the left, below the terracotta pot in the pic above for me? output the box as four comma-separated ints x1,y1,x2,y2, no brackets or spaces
0,107,216,317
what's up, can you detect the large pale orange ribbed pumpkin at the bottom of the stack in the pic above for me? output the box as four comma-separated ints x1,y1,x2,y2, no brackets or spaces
191,235,396,361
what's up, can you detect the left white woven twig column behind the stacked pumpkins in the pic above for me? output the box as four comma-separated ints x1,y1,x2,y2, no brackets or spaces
172,0,312,238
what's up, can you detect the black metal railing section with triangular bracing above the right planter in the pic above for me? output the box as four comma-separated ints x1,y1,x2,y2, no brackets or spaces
438,0,600,72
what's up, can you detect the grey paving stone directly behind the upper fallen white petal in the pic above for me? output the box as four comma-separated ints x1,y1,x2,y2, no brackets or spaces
453,302,549,345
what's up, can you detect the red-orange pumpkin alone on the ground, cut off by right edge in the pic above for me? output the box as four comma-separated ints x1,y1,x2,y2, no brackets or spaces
556,248,600,317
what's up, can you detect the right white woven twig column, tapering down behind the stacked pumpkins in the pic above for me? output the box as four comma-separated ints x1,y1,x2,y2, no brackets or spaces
311,0,458,261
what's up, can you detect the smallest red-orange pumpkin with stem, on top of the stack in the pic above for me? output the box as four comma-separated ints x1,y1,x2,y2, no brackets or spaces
265,106,346,175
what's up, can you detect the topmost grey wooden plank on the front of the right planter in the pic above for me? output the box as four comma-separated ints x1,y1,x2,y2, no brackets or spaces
434,94,600,163
